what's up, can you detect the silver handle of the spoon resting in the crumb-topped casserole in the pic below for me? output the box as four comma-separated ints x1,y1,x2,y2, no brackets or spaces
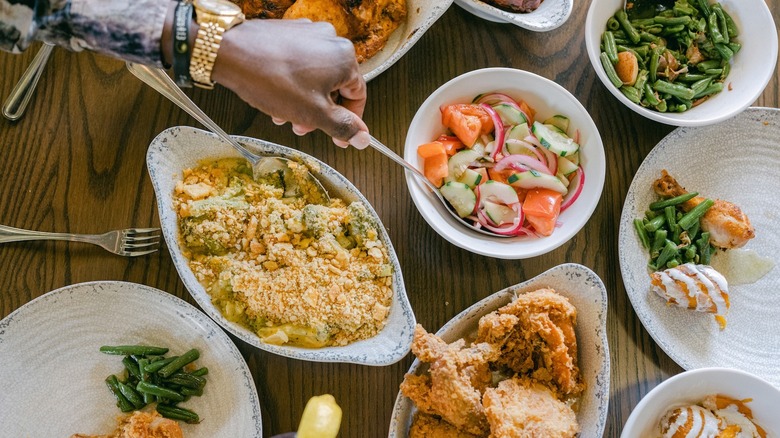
127,62,258,164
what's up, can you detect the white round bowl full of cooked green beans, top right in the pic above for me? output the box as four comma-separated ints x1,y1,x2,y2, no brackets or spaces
585,0,778,126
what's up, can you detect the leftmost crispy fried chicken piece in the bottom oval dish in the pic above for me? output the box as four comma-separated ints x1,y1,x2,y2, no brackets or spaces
401,324,498,435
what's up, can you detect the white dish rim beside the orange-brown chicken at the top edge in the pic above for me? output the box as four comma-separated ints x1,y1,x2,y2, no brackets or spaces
360,0,454,81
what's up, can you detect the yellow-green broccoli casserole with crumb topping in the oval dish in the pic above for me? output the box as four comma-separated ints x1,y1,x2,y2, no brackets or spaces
174,158,393,348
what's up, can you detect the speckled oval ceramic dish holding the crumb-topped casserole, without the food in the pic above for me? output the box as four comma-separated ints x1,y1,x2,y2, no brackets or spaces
146,127,415,366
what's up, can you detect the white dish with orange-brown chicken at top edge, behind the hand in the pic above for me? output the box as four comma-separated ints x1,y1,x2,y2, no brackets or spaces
231,0,454,81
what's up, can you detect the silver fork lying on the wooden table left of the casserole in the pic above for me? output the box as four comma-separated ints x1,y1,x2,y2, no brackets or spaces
0,225,160,257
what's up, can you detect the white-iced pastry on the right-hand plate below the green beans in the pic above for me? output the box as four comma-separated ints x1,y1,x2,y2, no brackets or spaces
650,263,729,329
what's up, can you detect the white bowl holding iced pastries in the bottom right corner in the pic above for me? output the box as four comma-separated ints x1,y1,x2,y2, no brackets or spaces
620,368,780,438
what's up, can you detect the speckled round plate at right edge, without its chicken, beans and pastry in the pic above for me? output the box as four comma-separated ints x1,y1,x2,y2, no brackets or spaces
618,108,780,386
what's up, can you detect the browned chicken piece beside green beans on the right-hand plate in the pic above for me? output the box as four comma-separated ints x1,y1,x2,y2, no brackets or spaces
653,170,756,249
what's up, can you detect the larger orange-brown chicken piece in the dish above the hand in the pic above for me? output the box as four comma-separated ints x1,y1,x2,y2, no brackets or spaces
284,0,406,62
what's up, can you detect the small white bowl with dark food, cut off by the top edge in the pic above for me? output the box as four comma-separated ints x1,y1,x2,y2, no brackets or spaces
455,0,574,32
